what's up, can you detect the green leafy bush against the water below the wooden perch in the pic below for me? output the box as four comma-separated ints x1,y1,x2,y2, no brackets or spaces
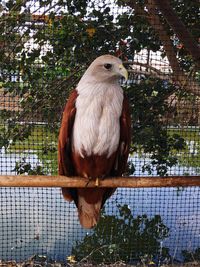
72,205,170,264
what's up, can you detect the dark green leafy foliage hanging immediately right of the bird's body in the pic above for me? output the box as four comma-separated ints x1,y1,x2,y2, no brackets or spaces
127,77,185,175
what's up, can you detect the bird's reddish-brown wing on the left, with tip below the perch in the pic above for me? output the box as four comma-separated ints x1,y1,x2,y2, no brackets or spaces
58,90,78,201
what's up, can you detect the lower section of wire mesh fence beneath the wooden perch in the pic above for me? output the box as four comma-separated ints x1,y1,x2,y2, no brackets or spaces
0,187,200,265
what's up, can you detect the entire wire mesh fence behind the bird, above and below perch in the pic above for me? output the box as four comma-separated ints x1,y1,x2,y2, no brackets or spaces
0,0,200,266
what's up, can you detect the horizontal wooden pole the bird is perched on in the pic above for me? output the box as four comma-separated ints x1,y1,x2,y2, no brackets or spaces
0,175,200,188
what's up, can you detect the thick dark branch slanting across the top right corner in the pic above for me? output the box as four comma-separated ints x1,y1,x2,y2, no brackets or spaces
155,0,200,67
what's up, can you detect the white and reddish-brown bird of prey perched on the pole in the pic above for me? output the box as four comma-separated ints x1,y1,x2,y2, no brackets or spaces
58,54,131,229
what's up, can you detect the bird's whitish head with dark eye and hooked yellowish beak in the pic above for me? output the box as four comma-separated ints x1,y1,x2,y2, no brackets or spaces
79,55,128,82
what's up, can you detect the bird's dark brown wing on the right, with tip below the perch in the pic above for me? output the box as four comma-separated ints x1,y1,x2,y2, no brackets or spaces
102,96,131,206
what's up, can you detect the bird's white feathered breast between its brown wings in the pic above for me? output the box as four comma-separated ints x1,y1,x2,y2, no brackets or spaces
72,83,123,157
